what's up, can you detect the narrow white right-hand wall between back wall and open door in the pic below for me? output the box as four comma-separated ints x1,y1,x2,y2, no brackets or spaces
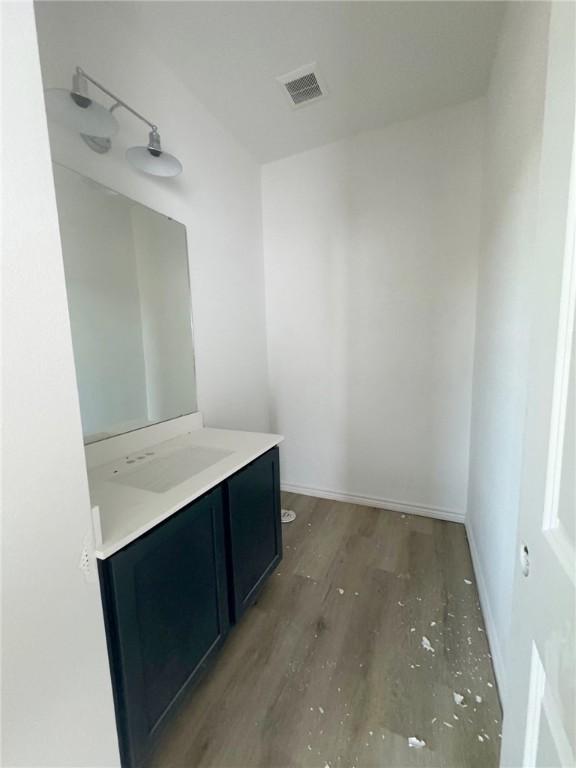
467,3,549,689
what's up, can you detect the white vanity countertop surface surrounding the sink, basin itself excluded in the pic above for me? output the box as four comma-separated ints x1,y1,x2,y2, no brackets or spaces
88,427,284,560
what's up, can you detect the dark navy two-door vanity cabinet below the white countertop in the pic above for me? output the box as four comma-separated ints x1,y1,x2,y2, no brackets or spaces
99,448,282,768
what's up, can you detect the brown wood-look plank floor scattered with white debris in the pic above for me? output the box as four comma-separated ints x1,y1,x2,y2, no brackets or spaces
147,494,501,768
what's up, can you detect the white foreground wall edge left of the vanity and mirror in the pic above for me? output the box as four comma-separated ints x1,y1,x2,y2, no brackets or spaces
1,1,119,768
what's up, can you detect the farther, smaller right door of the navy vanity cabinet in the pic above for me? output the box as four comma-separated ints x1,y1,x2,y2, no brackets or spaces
227,448,282,620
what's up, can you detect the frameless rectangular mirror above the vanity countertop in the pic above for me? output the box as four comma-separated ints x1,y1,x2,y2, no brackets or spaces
54,164,197,443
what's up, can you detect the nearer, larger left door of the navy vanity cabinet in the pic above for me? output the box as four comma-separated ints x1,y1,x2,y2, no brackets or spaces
101,489,229,766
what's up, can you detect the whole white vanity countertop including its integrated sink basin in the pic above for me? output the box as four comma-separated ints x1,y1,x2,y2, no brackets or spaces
88,428,283,560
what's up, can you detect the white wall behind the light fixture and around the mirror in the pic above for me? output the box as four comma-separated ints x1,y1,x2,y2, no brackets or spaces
36,2,268,430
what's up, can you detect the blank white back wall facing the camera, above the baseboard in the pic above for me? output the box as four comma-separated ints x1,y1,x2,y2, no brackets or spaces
263,100,484,518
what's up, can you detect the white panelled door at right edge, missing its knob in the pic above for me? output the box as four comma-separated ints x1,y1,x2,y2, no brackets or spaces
501,2,576,768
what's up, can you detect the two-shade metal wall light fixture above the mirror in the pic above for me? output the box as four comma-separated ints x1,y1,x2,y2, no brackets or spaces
46,67,182,176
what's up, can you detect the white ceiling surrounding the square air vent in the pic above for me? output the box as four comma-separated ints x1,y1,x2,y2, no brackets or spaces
57,0,503,162
